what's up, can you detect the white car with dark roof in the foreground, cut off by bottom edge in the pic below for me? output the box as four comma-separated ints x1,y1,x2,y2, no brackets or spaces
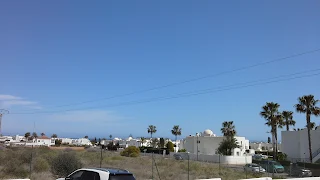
57,168,136,180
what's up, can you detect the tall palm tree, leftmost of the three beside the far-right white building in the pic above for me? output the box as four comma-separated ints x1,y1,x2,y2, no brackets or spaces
260,102,282,160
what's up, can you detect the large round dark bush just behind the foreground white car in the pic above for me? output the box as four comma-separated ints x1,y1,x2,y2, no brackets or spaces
51,152,82,177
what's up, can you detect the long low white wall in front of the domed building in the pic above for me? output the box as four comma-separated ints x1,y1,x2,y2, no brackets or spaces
170,153,252,165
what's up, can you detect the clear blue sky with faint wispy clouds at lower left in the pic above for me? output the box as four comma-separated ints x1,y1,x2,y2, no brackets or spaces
0,0,320,140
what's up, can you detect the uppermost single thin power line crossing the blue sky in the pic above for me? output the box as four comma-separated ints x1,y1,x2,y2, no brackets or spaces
26,48,320,108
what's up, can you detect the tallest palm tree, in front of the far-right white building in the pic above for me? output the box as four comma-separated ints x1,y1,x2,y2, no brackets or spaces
295,95,320,163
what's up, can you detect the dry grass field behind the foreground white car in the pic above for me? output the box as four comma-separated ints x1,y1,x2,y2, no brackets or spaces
0,149,262,180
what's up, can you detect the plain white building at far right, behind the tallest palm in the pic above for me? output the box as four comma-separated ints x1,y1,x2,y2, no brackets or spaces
281,126,320,162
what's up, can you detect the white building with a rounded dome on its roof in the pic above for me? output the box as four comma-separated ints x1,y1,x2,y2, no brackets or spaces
179,129,249,156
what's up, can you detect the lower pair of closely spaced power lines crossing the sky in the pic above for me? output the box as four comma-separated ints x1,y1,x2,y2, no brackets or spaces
10,68,320,114
